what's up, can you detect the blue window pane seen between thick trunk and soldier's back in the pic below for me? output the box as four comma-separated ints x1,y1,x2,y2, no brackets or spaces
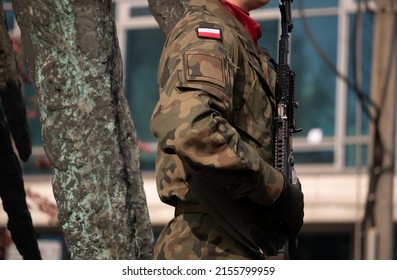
125,28,165,170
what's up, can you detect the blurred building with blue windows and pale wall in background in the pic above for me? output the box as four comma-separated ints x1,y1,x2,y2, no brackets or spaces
0,0,397,259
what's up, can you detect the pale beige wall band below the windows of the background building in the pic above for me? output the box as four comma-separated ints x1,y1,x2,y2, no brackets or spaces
0,172,397,227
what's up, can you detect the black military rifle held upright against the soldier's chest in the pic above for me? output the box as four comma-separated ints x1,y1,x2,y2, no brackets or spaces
274,0,301,259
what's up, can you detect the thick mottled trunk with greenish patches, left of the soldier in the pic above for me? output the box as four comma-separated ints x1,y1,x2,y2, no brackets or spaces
13,0,152,259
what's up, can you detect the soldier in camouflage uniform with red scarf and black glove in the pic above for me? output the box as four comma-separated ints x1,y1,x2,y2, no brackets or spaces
150,0,303,259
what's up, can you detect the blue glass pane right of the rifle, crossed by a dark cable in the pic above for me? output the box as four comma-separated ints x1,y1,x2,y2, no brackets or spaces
291,16,337,137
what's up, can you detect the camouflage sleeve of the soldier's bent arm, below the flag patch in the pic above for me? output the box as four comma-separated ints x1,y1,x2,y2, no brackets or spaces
151,25,284,205
